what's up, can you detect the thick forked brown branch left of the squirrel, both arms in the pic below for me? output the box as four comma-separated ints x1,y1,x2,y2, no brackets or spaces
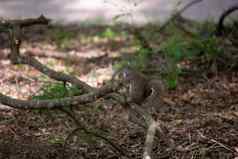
0,16,114,109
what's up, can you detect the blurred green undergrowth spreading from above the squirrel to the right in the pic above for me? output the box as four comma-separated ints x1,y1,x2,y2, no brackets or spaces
116,22,223,89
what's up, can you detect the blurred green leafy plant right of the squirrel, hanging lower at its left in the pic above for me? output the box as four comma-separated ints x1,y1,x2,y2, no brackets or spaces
161,27,223,89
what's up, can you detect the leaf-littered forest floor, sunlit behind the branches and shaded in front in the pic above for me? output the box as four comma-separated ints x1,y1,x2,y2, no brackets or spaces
0,23,238,159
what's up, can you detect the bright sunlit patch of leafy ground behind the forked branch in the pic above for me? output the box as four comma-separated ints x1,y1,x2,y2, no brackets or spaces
0,26,133,99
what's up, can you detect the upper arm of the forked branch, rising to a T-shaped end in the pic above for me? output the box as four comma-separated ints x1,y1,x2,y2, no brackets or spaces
0,16,95,92
